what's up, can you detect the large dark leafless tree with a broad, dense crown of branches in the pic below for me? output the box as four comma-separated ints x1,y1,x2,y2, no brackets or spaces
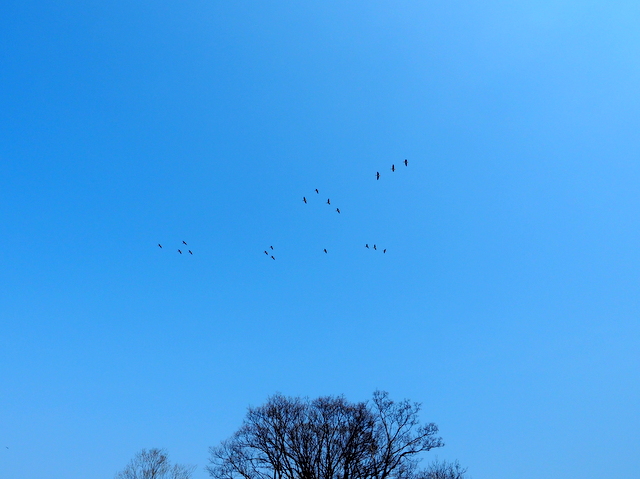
207,391,444,479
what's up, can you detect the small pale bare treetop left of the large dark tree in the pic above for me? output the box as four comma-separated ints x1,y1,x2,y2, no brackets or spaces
115,448,196,479
